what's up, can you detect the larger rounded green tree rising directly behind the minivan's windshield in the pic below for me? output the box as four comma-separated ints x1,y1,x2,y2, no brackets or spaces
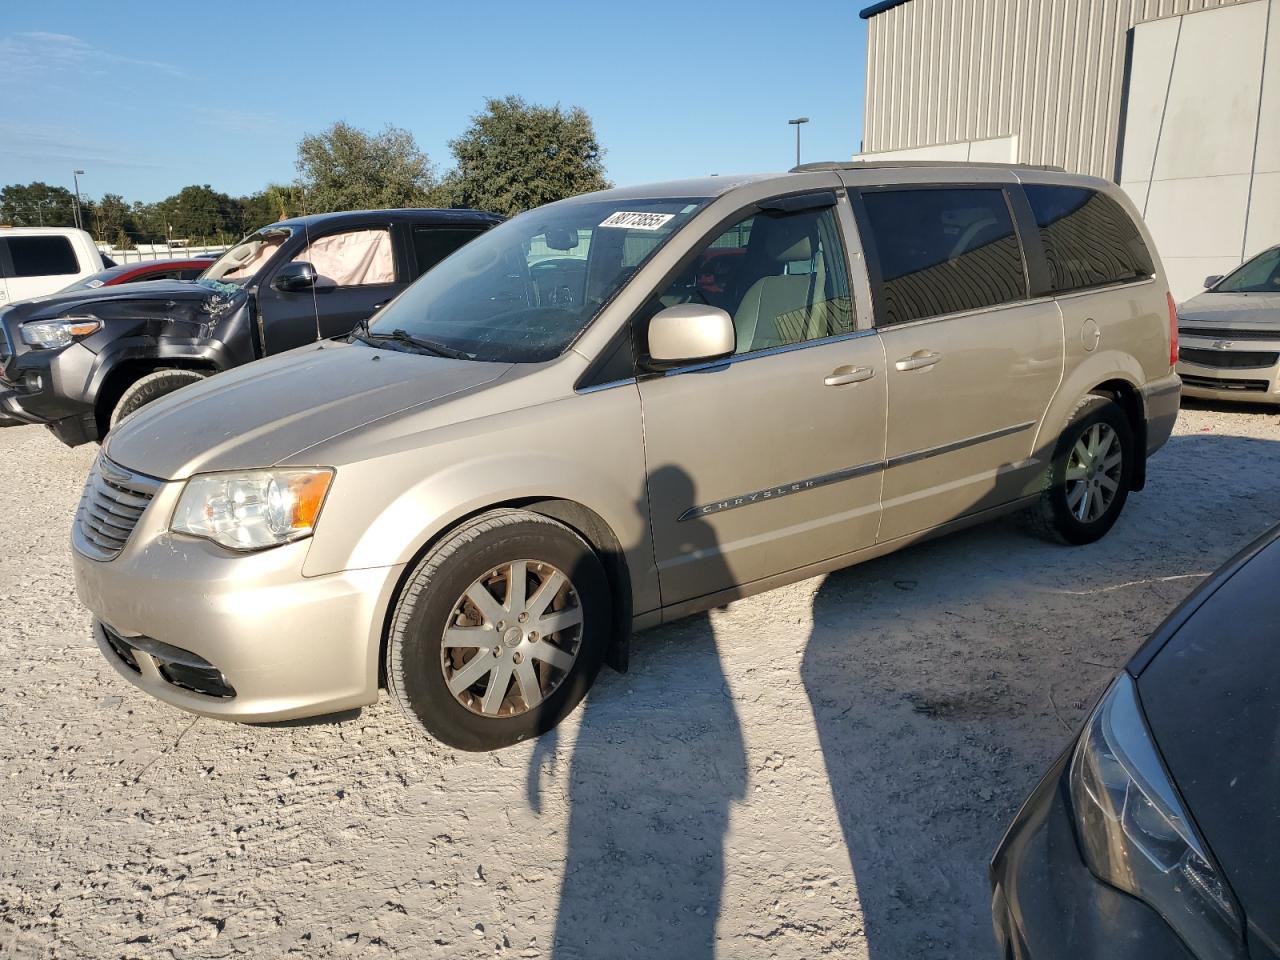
447,96,609,216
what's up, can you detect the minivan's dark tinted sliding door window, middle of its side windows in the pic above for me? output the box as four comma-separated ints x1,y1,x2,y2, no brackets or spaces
863,188,1027,326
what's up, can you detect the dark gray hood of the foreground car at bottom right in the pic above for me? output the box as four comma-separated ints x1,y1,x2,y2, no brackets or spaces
1138,541,1280,942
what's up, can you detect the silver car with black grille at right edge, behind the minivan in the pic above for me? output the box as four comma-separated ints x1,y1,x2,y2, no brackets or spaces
1178,246,1280,403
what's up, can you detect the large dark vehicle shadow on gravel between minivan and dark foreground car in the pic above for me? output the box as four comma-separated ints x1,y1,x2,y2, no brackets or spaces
800,434,1280,960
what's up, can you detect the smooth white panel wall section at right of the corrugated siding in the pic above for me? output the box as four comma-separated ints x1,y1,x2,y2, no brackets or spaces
1119,0,1280,300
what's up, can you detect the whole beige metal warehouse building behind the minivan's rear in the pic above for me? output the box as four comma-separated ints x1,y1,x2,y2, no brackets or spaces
855,0,1280,300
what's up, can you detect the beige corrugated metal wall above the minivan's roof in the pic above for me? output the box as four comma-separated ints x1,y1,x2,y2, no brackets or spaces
863,0,1251,178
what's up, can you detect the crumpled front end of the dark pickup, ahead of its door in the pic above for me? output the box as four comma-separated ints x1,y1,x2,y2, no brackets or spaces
0,280,260,447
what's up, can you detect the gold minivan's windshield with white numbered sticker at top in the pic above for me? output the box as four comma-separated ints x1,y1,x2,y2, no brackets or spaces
369,197,707,364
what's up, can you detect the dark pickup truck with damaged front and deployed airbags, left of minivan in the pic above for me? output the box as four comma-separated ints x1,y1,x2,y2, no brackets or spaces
0,210,502,447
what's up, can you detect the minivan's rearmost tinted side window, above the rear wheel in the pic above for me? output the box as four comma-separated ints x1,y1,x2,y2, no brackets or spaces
1025,184,1156,291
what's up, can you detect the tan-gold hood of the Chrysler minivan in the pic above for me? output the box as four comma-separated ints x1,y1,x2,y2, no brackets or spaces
104,342,512,480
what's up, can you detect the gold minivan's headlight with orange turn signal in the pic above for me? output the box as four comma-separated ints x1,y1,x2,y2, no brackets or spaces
169,467,333,550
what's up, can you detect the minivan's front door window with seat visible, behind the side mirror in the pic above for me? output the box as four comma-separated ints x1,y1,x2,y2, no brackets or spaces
659,207,854,353
